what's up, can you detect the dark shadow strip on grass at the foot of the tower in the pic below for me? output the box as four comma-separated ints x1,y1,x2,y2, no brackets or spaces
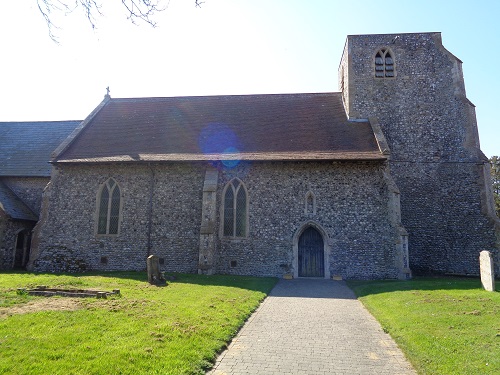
347,276,500,297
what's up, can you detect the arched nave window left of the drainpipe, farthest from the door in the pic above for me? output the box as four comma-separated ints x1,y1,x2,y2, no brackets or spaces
97,178,121,234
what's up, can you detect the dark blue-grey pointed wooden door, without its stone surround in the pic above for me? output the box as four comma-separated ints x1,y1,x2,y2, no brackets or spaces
297,226,325,277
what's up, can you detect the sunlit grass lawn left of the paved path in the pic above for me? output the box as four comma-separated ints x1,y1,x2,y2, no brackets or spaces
0,272,276,375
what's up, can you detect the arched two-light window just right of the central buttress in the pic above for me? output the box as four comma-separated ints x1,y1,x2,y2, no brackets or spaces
223,178,248,237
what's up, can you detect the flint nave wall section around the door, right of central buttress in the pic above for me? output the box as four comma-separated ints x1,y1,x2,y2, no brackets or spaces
217,162,397,279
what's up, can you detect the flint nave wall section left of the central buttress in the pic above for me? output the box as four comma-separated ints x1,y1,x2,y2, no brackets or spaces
32,164,203,272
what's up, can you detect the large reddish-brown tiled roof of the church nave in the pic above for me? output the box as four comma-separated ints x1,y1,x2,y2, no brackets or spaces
53,93,385,163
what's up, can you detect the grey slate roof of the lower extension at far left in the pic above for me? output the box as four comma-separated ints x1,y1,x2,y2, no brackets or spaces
0,121,81,177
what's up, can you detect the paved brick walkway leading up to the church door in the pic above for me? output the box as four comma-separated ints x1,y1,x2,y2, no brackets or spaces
208,279,416,375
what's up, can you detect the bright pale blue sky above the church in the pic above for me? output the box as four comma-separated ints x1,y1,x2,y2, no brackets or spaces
0,0,500,156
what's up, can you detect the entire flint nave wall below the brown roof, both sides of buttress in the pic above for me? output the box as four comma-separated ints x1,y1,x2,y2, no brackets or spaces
33,162,398,278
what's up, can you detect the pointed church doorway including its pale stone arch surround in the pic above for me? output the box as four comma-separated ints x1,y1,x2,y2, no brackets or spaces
292,221,330,279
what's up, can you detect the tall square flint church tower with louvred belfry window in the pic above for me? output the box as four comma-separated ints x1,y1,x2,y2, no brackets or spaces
339,33,500,274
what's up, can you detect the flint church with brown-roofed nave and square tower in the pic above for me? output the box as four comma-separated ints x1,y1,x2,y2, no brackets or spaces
1,33,500,279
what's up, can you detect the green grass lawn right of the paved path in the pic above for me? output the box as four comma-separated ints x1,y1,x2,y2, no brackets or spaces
348,278,500,375
